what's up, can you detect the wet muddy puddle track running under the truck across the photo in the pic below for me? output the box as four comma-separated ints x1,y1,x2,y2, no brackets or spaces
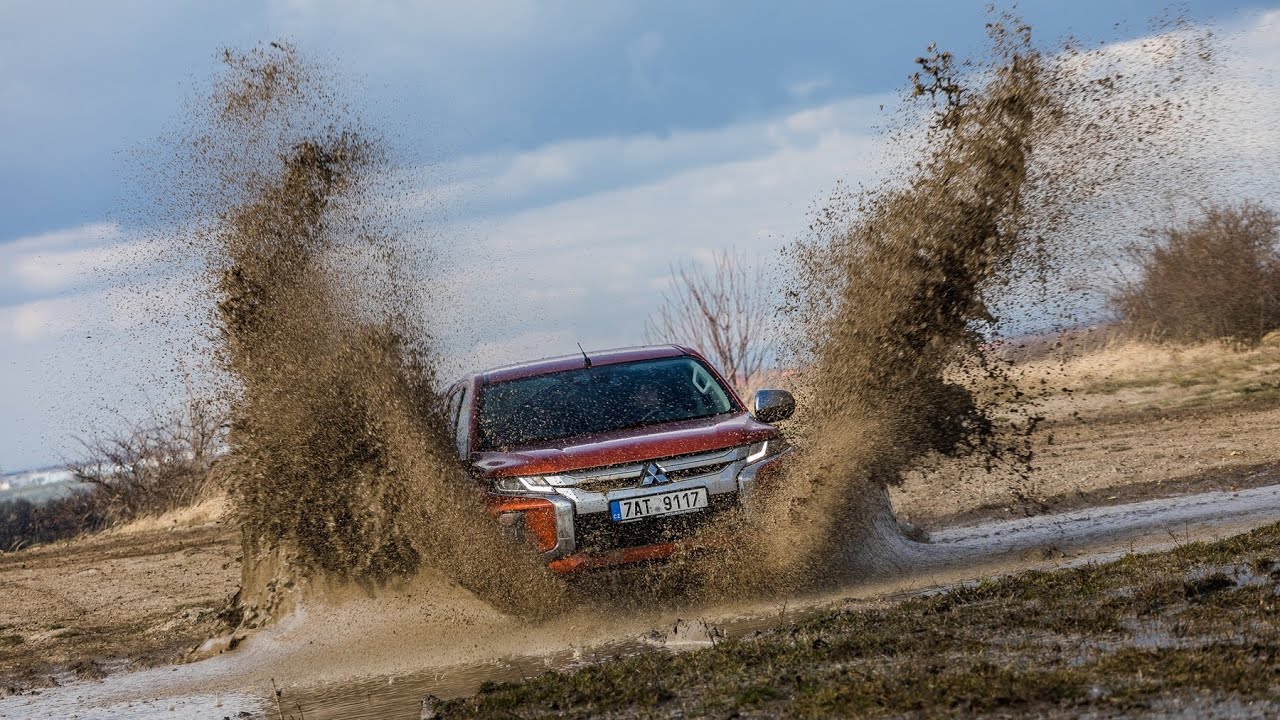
0,486,1280,719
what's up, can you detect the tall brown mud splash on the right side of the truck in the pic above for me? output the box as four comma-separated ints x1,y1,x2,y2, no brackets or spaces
733,18,1203,587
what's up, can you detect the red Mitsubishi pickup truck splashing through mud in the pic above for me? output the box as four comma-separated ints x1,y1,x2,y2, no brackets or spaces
447,345,795,573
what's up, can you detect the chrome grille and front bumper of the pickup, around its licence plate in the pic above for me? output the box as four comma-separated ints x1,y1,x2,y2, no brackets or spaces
490,447,791,573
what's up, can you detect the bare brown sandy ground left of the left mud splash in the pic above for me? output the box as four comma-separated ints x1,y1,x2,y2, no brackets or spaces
0,502,239,693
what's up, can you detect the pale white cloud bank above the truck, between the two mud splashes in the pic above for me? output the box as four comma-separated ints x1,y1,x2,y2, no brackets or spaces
422,99,879,369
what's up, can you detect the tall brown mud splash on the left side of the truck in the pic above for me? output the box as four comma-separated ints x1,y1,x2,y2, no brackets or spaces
167,44,562,623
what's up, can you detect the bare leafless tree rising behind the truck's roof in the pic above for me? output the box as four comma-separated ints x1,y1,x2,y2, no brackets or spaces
645,250,772,393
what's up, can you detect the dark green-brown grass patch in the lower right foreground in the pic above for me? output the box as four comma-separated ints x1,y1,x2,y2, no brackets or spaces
439,525,1280,717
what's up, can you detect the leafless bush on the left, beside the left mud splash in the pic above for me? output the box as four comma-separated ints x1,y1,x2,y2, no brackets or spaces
70,396,227,523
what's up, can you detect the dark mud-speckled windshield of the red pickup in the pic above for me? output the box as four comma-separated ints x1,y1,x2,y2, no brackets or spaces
477,357,733,450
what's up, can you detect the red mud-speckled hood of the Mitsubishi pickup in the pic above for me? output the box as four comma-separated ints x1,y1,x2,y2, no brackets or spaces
471,413,780,477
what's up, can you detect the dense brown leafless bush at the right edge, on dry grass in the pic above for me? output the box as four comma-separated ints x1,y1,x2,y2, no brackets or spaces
1111,202,1280,343
